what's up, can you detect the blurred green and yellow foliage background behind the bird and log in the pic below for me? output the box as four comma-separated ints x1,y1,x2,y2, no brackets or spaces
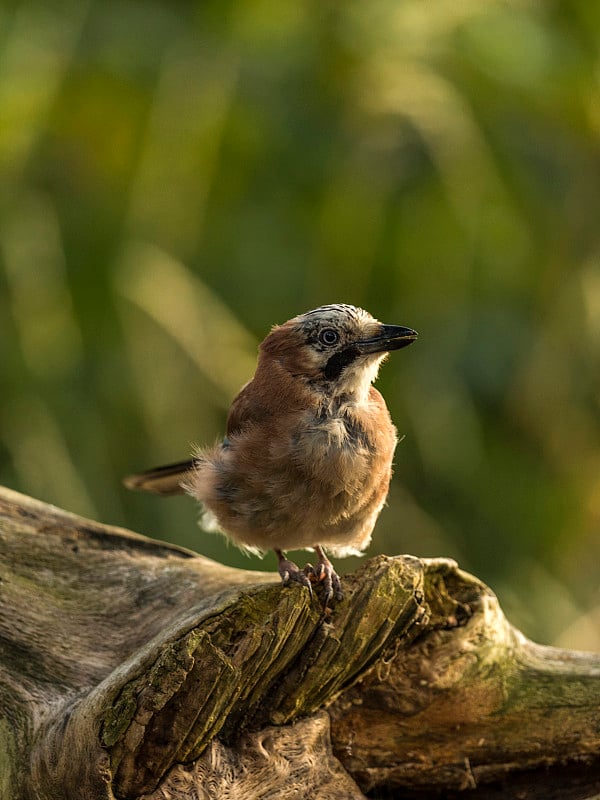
0,0,600,649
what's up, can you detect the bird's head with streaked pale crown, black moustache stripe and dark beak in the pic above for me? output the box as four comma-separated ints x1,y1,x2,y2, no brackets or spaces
260,304,417,399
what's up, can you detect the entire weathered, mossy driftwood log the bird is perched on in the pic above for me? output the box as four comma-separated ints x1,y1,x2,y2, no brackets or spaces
0,482,600,800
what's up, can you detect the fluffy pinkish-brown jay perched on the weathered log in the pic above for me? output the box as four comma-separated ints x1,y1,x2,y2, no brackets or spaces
124,303,417,609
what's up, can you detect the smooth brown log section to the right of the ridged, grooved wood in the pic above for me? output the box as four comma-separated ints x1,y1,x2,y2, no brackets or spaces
329,560,600,800
